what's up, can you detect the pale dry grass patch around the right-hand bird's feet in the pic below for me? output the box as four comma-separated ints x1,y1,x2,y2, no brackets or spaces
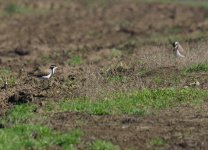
62,42,208,99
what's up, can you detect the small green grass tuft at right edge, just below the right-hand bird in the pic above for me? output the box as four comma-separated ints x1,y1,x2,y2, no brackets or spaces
183,64,208,73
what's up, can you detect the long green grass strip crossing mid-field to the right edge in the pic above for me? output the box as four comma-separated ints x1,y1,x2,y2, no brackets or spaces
45,88,208,115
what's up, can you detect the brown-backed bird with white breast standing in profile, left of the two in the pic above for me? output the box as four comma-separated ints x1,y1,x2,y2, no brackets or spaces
33,65,58,87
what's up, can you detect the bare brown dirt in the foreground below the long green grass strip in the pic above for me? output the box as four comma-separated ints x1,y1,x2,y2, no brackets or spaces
50,103,208,149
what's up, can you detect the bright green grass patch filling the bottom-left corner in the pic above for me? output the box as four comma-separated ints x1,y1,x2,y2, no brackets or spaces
0,104,83,150
